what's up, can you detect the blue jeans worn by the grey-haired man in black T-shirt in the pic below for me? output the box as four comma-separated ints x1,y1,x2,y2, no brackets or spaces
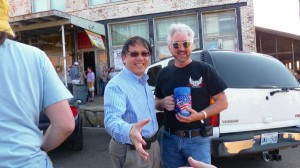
160,131,211,168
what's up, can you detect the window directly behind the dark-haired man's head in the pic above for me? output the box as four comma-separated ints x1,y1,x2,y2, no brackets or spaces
110,21,149,69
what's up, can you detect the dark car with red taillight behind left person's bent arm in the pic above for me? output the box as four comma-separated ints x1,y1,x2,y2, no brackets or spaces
38,100,83,151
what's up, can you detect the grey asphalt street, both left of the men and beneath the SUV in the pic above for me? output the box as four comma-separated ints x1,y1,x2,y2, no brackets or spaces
49,127,300,168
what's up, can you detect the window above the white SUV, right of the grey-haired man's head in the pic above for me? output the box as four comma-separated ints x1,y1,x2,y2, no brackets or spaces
202,11,238,50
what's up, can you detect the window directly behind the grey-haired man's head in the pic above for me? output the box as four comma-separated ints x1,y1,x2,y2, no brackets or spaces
155,15,199,62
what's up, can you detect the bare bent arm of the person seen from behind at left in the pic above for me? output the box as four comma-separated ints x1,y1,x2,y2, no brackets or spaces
41,100,75,152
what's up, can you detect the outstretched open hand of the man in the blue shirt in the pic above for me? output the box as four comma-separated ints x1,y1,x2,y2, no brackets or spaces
129,119,150,160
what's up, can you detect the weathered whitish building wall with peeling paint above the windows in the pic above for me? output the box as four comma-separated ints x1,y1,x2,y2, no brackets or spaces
9,0,256,51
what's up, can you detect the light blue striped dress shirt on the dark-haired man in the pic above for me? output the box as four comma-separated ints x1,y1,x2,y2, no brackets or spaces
104,68,158,144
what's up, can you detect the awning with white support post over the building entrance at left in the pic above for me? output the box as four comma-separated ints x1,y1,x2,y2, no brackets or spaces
10,10,105,86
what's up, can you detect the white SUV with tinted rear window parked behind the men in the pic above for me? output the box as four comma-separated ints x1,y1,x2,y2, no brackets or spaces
146,50,300,161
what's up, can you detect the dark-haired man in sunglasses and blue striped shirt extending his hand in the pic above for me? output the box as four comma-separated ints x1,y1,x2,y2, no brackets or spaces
104,37,160,168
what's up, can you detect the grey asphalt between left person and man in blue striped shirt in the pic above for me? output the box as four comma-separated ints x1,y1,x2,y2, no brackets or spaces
49,127,113,168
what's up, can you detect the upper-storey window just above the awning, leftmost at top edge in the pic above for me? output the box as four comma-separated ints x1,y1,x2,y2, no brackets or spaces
32,0,66,13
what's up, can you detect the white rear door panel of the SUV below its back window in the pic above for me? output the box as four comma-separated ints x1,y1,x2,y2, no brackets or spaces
219,88,300,134
